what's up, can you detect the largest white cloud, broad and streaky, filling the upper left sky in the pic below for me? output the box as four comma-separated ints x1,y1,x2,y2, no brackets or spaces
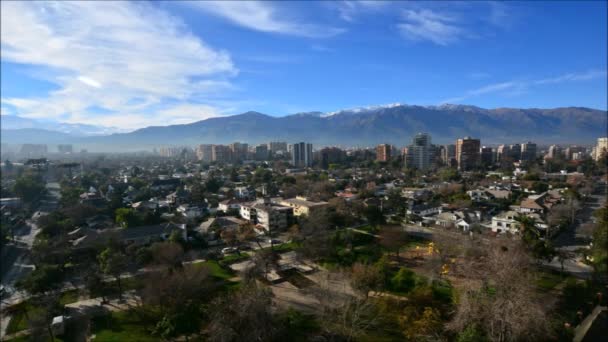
1,1,238,127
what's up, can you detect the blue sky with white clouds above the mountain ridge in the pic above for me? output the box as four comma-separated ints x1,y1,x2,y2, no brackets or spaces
0,1,608,129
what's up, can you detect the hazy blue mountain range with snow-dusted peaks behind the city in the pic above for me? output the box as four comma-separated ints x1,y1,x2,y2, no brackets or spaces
2,104,608,151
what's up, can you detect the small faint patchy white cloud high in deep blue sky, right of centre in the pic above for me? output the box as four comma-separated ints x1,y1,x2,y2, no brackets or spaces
397,9,467,46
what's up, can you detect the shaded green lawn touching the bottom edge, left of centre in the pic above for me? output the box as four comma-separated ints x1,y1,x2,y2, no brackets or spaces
91,311,159,342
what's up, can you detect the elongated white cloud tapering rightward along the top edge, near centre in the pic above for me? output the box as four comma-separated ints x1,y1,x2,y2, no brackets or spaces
189,1,344,38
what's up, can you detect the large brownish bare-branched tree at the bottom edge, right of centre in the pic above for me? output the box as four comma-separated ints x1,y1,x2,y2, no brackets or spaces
447,241,548,341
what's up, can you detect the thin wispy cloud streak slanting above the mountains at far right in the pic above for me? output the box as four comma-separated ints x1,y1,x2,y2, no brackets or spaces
439,70,607,104
